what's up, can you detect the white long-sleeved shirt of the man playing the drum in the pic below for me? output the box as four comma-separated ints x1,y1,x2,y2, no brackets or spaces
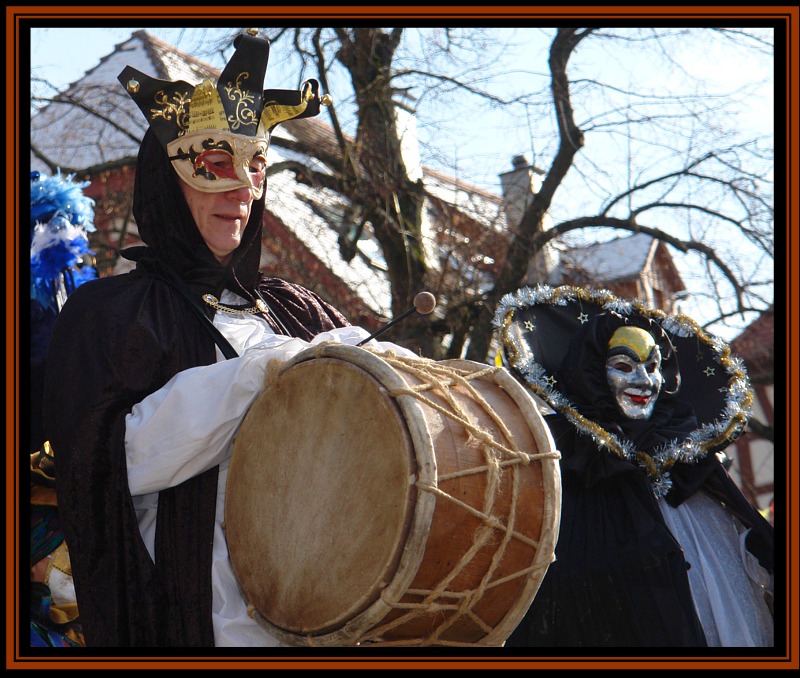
125,291,414,647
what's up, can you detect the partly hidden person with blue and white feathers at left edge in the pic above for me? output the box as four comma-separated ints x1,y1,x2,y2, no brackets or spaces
25,172,97,647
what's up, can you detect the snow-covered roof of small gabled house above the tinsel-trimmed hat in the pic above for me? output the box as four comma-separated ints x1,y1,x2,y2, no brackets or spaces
561,233,656,282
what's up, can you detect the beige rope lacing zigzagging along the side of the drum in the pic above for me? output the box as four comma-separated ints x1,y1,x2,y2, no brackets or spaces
334,353,560,646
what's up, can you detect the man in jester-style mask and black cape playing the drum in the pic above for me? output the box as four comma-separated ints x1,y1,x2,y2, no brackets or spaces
44,29,412,647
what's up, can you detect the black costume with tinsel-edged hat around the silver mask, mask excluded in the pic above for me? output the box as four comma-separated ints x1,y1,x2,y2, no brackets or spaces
496,287,773,648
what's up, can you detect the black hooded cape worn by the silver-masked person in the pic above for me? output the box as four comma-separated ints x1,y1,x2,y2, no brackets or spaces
506,314,773,648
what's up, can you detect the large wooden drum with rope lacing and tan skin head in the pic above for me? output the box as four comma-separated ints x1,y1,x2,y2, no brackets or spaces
225,343,561,646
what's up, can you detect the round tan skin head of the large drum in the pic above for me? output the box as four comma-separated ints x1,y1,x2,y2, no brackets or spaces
225,358,416,635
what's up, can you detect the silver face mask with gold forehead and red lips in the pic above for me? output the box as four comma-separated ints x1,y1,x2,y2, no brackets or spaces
606,326,664,419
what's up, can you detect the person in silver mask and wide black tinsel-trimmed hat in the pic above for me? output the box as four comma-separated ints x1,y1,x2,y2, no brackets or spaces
495,287,773,648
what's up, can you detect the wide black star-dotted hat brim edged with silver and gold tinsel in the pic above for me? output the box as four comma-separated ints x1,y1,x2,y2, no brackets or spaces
493,285,753,497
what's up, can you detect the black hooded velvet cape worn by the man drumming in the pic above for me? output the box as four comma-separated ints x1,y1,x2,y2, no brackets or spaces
44,131,348,647
